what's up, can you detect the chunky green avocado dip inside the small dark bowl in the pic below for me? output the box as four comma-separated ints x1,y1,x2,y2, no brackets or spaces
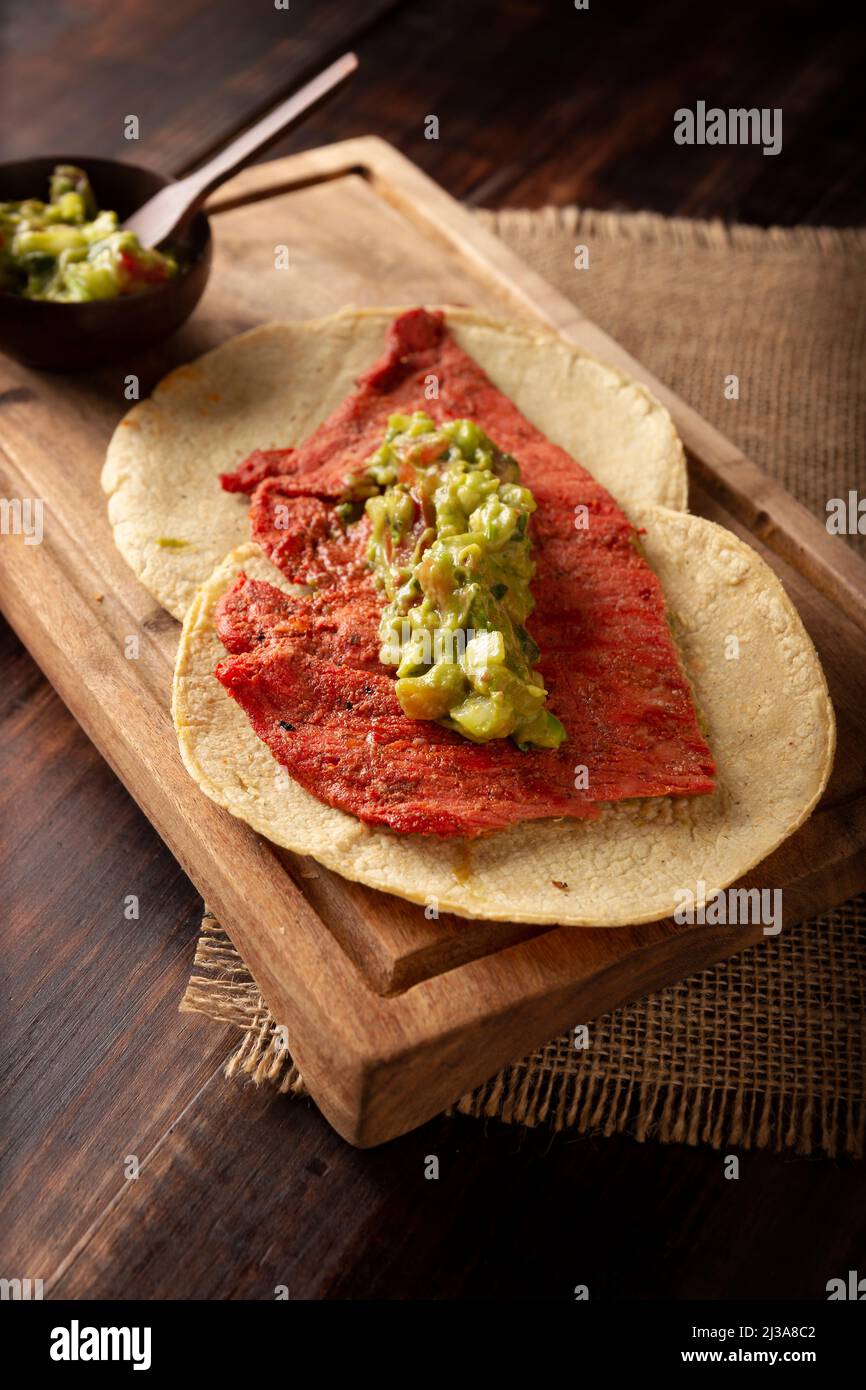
0,164,178,303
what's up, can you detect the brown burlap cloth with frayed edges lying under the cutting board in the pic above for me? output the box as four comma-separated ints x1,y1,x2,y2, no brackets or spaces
182,209,866,1156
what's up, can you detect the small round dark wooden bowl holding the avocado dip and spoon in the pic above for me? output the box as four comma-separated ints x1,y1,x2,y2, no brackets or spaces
0,154,213,371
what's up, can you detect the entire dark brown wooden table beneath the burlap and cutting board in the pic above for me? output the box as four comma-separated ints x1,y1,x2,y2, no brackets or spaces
0,0,866,1298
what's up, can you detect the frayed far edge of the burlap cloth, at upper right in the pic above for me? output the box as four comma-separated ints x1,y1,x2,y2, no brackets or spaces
477,204,866,256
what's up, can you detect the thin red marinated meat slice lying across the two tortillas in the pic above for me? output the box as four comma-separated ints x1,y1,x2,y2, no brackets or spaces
217,310,714,835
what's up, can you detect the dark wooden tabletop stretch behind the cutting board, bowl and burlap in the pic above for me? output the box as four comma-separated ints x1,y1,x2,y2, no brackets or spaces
0,0,866,225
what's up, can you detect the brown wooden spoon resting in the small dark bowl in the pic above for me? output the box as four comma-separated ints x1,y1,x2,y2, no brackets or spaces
124,53,357,246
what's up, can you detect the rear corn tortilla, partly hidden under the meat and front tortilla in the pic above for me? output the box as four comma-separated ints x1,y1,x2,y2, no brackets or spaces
103,309,687,619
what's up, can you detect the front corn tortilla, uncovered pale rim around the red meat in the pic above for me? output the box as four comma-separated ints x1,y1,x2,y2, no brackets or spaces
172,507,835,926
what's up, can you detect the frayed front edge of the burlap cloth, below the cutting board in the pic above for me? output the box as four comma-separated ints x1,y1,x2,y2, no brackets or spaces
181,913,866,1158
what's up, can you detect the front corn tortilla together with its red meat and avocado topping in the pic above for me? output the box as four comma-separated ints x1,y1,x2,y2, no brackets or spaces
166,310,834,926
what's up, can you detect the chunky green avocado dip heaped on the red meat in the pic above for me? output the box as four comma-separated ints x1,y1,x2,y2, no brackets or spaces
342,411,566,748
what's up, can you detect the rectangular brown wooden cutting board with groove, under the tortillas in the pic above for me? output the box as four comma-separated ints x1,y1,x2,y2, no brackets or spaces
0,138,866,1145
